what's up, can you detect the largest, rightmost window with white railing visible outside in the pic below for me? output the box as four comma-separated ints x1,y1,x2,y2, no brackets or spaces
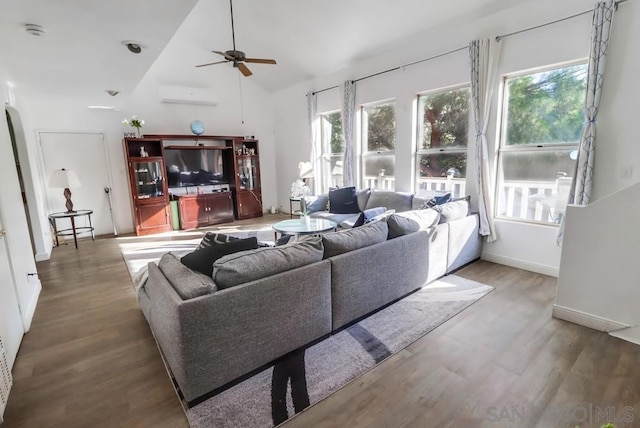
497,64,587,224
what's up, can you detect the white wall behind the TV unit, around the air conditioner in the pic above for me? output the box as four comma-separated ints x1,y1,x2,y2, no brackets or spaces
122,1,278,216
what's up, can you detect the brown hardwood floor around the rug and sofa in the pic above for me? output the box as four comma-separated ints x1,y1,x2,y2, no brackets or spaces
2,216,640,428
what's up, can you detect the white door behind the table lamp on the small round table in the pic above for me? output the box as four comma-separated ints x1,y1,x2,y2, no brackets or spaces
40,132,113,235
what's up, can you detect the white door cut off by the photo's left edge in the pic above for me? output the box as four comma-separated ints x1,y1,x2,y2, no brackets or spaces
0,212,24,367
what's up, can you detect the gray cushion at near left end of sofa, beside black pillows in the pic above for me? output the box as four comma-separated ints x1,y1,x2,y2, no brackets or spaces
158,253,217,300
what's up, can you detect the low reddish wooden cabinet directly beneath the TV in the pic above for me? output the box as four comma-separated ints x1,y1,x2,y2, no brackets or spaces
178,192,234,229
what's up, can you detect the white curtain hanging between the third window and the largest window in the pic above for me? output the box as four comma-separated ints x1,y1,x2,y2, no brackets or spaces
469,39,501,242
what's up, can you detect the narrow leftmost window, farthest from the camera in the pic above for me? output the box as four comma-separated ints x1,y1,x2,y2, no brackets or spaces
320,111,344,192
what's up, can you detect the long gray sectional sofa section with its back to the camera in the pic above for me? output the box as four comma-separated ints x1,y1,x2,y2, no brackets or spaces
138,192,482,404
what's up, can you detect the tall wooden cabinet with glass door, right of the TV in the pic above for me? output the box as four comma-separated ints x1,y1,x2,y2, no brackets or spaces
232,139,264,220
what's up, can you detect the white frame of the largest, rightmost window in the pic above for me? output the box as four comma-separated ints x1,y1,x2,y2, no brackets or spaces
494,58,588,228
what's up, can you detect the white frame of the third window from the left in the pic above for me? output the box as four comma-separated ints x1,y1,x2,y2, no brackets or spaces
412,82,473,197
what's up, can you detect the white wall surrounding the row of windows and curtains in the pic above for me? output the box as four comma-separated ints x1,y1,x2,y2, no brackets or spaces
275,0,604,275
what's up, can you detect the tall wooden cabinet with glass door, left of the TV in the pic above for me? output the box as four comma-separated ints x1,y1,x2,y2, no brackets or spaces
124,138,171,235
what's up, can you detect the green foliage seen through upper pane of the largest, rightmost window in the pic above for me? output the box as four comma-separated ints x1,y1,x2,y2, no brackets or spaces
506,64,587,145
